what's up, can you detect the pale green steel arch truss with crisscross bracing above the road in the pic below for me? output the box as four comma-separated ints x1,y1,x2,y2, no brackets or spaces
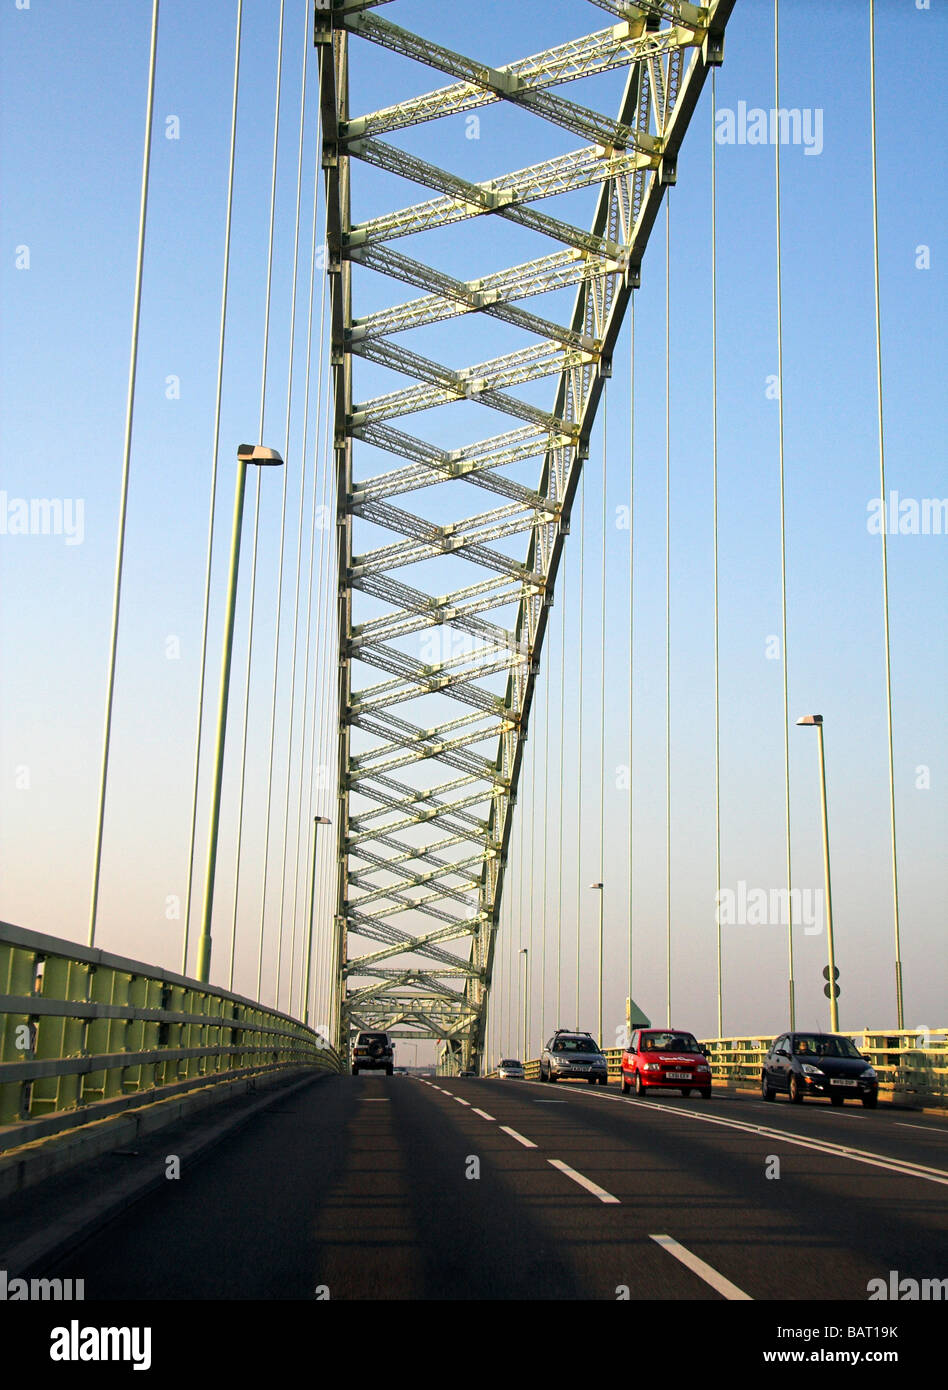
316,0,734,1066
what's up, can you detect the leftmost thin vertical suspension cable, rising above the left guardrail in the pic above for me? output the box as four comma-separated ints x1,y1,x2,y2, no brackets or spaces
89,0,158,947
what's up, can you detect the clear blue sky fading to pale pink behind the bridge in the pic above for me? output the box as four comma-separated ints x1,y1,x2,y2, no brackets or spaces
0,0,948,1036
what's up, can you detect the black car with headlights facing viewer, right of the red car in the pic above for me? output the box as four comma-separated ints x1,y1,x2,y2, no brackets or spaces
760,1033,878,1109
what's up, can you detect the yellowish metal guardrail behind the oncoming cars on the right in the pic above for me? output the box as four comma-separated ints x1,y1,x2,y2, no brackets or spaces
489,1029,948,1106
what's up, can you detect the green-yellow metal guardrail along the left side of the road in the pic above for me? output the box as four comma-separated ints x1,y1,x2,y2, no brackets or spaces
0,923,341,1126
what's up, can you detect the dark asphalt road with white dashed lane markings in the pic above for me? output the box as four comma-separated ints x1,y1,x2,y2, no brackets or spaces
53,1074,948,1301
